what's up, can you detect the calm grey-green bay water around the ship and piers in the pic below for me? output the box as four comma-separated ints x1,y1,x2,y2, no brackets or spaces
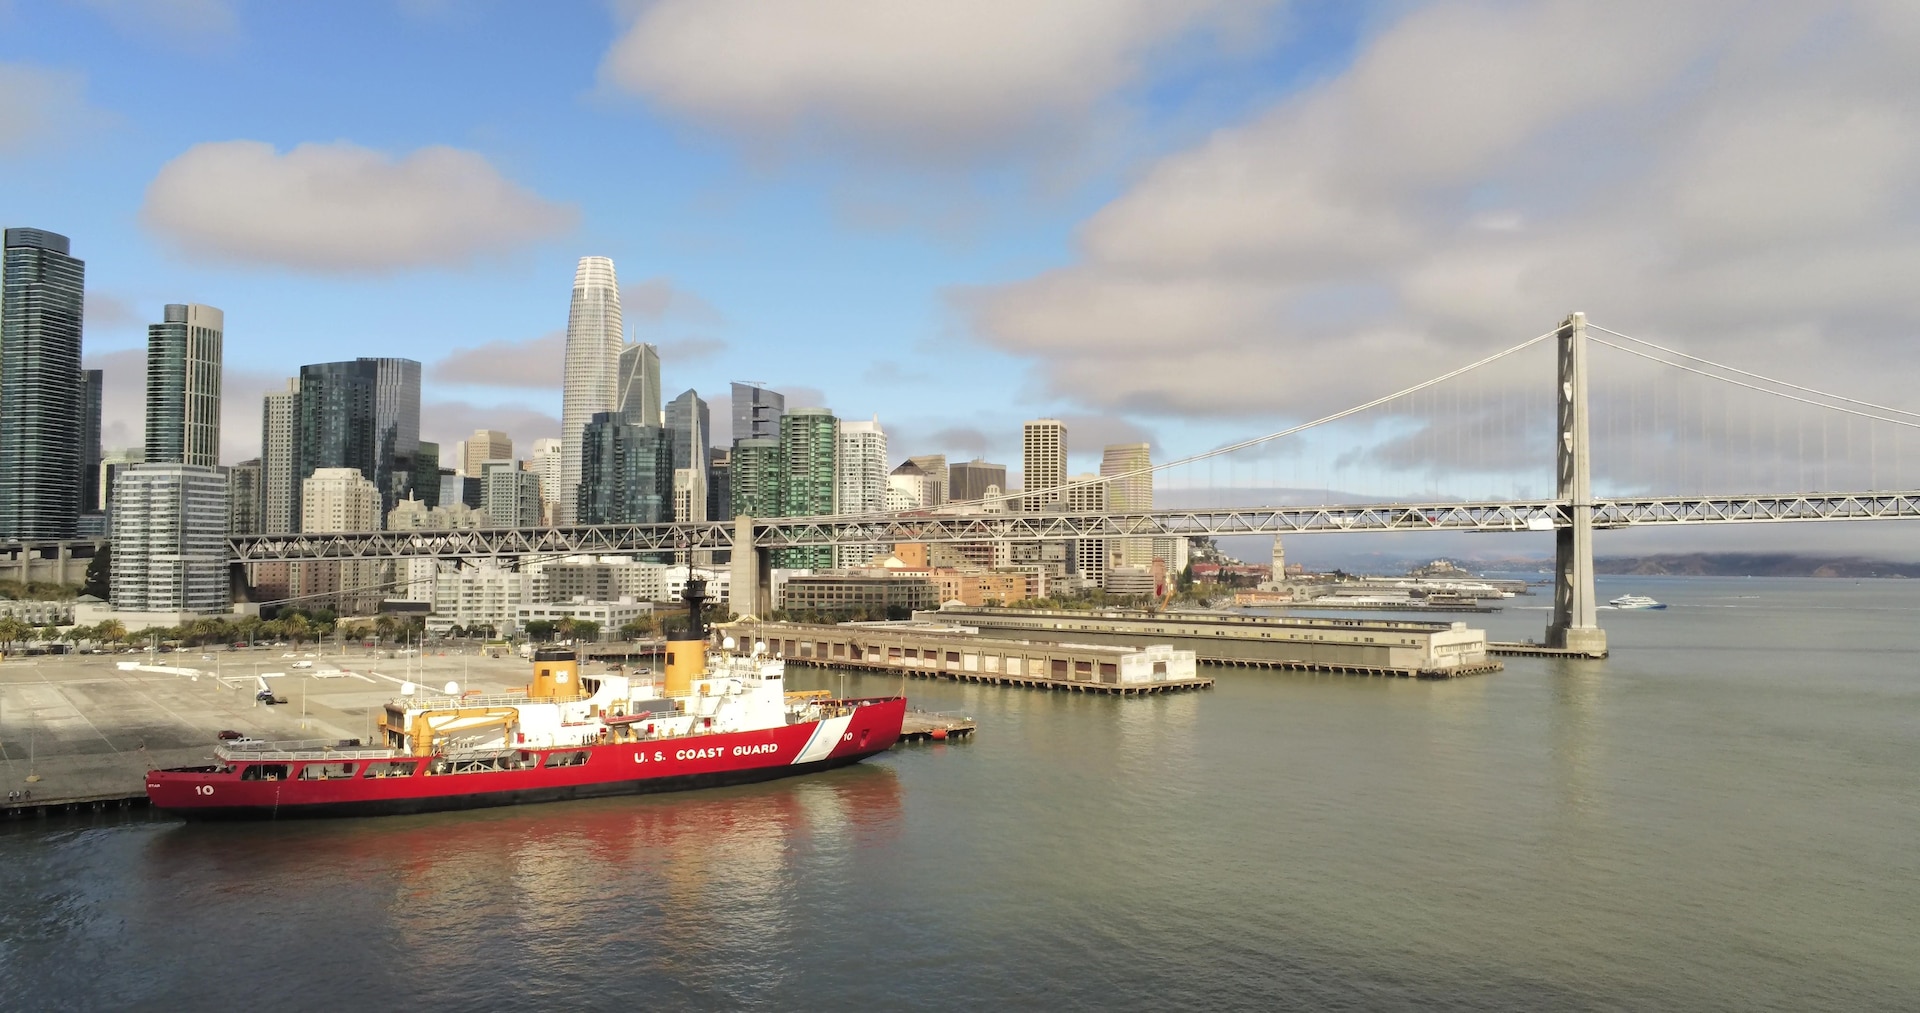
0,577,1920,1009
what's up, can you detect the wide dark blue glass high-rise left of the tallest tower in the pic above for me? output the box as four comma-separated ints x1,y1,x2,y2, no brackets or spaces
294,359,422,516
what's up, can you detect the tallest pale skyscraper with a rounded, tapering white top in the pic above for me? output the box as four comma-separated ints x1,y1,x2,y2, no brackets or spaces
553,257,622,524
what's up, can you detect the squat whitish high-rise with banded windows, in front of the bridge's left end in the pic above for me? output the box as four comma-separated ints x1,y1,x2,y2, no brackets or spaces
108,464,232,612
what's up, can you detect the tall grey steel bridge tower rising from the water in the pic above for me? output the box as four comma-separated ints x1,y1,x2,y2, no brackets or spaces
1548,313,1607,658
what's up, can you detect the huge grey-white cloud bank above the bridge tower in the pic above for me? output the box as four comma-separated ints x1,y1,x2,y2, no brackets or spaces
956,0,1920,416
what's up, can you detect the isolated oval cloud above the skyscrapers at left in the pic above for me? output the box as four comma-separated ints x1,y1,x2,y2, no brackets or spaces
140,140,576,272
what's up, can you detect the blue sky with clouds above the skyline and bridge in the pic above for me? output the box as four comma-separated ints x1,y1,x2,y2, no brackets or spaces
0,0,1920,556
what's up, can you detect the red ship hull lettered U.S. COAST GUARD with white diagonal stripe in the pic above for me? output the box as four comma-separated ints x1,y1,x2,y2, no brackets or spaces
146,696,906,819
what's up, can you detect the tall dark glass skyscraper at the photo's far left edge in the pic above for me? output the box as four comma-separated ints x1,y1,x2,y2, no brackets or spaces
0,228,86,539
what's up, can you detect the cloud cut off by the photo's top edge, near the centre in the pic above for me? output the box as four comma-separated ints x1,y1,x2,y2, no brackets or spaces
601,0,1271,155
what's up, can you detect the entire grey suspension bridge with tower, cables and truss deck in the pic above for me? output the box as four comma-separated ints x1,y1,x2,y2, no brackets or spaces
7,313,1920,656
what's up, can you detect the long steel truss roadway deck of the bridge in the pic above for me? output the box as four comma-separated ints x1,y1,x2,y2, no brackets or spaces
214,491,1920,562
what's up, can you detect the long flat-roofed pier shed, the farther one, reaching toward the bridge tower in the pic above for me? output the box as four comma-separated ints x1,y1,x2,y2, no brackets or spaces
914,608,1501,679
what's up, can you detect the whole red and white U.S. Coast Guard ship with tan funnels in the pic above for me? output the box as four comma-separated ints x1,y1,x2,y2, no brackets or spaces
146,579,906,819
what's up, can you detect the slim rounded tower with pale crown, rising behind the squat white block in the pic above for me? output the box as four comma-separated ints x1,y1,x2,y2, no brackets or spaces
146,303,227,468
